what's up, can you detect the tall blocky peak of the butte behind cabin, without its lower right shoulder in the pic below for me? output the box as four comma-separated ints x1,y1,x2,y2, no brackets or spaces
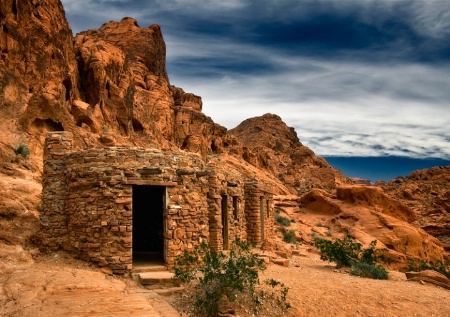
75,18,173,142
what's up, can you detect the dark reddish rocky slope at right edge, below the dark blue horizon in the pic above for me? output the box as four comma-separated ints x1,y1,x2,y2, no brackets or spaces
383,166,450,254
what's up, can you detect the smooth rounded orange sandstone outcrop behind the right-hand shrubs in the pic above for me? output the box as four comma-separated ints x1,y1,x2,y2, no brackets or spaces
275,185,444,269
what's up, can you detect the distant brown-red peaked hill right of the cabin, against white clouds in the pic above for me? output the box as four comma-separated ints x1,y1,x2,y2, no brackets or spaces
229,114,347,193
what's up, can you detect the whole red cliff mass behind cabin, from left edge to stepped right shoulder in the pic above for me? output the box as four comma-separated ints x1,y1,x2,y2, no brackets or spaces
0,0,236,166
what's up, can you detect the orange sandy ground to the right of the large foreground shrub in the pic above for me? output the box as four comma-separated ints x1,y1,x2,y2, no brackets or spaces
263,254,450,317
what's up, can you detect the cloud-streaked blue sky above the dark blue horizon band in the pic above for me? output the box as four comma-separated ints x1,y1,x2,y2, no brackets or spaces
62,0,450,160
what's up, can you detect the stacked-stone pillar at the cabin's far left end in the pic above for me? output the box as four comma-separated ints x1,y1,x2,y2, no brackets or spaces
40,131,73,250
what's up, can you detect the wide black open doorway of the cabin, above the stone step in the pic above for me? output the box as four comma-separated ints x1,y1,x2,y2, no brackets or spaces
133,185,166,265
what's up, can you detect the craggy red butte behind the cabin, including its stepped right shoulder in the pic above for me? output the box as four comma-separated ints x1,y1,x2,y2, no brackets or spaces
72,18,236,159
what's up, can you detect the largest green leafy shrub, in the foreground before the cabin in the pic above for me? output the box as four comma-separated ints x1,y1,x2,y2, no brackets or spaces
174,239,290,316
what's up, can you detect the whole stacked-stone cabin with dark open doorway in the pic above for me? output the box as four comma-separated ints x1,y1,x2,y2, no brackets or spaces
40,132,274,274
